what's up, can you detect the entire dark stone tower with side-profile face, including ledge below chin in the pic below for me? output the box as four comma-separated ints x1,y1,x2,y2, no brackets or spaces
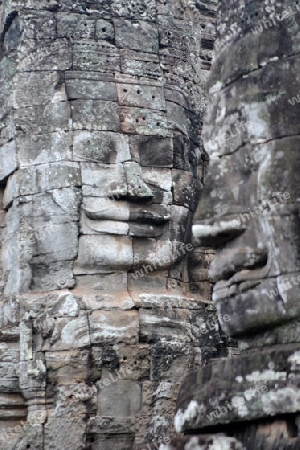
170,0,300,450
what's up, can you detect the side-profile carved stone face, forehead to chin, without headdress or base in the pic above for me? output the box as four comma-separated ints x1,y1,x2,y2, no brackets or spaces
195,62,300,335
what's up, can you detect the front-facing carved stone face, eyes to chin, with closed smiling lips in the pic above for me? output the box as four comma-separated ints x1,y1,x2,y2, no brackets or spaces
74,132,202,275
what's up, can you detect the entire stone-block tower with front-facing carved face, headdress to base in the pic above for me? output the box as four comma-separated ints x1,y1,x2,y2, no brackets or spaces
0,0,221,450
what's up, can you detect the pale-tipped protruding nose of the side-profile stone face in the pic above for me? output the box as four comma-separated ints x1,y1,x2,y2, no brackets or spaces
193,219,247,248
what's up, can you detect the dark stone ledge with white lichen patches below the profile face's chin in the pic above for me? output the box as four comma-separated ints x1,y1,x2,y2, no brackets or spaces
175,344,300,432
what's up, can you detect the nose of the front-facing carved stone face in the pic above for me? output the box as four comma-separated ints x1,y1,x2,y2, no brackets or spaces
124,162,153,200
